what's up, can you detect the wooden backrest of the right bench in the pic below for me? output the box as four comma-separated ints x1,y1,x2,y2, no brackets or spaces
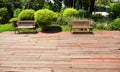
70,20,91,26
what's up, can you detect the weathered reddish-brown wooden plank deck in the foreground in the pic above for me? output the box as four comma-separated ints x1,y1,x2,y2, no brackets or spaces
0,31,120,72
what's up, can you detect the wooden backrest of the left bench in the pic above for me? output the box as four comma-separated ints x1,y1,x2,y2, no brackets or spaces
17,20,35,26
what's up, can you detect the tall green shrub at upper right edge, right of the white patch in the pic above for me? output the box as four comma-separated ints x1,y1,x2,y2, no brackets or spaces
110,3,120,18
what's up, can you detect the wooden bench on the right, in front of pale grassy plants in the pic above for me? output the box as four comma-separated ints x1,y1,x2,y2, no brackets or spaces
70,20,92,32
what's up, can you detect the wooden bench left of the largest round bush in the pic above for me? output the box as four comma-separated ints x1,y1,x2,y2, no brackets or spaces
15,20,37,33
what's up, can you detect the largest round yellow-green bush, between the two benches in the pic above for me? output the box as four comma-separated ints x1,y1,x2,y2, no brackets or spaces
34,9,57,27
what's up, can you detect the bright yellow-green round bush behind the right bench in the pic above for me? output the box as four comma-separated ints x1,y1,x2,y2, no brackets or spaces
63,8,78,17
